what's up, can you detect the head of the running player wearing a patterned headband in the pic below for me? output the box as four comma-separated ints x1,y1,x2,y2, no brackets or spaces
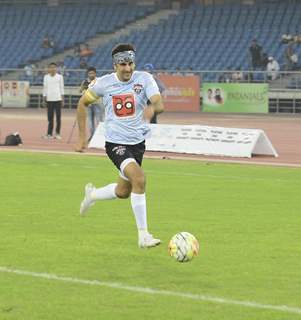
112,43,136,81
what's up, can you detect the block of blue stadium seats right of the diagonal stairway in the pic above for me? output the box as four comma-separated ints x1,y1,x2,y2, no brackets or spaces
81,1,301,80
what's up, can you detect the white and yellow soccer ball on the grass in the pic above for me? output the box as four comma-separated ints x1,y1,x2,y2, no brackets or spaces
168,232,199,262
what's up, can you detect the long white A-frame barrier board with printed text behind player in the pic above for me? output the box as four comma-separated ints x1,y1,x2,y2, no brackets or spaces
89,123,278,158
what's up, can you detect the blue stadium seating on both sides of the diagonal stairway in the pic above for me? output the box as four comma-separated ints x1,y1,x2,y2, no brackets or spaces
0,1,301,87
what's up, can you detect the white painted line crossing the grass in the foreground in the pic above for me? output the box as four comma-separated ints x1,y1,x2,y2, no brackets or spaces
0,266,301,314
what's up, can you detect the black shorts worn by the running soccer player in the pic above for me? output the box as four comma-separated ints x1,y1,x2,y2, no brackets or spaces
105,141,145,170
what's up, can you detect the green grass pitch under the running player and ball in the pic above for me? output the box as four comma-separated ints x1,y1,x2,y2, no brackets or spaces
0,152,301,320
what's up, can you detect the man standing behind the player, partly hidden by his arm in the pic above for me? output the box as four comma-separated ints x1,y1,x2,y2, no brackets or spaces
80,67,103,141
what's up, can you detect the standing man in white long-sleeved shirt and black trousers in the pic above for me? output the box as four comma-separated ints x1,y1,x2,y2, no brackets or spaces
43,62,64,139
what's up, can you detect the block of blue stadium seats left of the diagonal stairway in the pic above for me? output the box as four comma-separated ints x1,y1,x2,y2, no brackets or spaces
0,5,154,68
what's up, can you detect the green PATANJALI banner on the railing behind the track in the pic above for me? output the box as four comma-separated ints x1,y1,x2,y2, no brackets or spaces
202,83,269,113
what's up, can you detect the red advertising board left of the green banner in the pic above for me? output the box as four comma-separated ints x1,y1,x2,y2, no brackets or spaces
158,74,200,112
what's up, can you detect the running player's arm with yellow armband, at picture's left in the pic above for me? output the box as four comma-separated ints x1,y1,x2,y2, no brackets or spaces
75,89,99,152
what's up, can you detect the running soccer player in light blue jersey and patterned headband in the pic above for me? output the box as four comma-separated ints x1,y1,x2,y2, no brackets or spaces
76,44,164,248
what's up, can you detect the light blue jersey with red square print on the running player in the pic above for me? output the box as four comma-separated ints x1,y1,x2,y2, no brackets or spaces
89,71,160,145
